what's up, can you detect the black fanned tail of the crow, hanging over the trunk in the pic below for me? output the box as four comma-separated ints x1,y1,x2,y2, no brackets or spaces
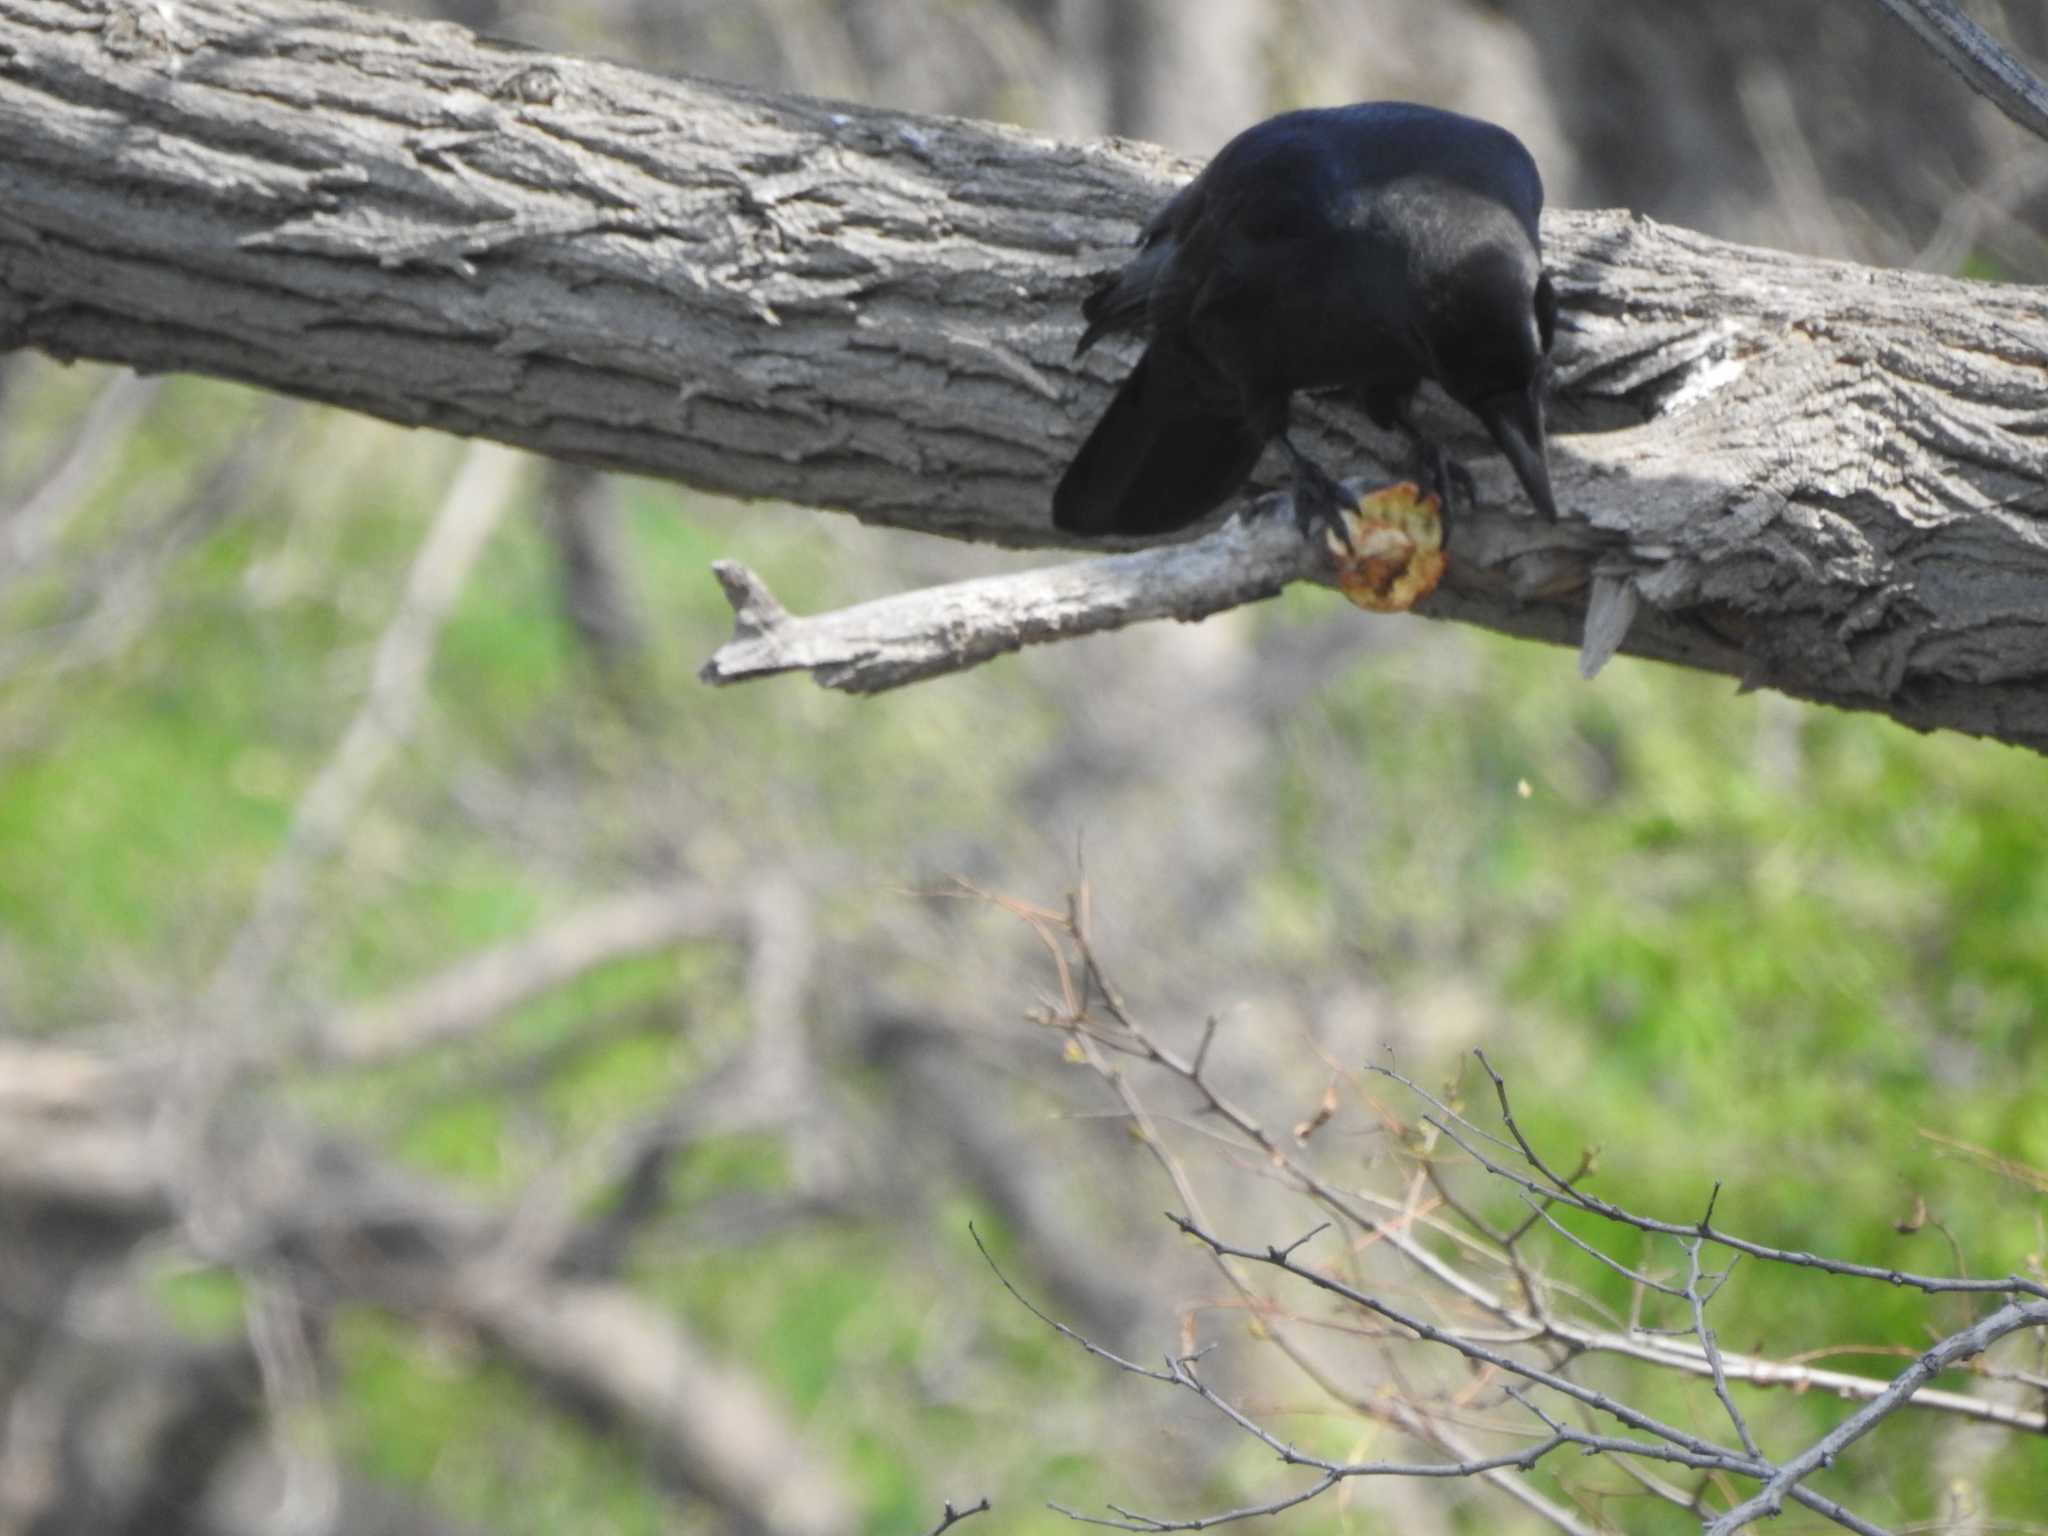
1053,350,1266,537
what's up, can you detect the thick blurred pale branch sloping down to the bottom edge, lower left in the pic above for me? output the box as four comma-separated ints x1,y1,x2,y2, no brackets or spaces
0,1049,852,1536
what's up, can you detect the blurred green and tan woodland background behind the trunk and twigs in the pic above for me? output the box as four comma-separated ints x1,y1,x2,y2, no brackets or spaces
0,0,2048,1536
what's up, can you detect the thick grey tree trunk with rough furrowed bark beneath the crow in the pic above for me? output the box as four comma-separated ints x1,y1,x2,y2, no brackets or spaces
0,0,2048,750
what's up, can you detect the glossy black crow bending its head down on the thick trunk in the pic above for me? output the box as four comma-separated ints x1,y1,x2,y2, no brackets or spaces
1053,102,1556,535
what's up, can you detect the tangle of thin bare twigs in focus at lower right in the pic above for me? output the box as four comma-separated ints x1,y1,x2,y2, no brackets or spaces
983,913,2048,1536
